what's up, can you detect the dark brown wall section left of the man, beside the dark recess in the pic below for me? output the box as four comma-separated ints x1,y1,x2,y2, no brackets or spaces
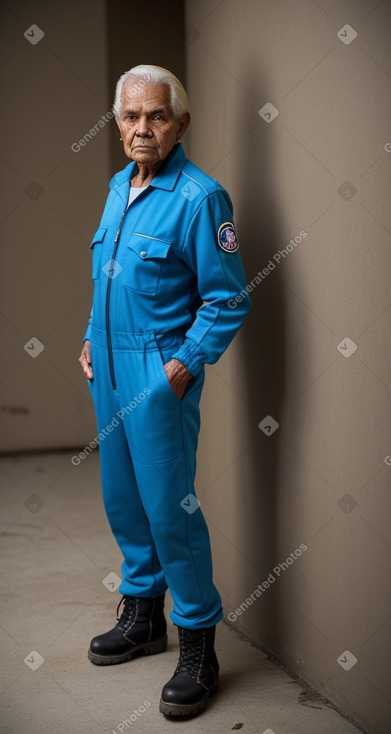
0,0,111,451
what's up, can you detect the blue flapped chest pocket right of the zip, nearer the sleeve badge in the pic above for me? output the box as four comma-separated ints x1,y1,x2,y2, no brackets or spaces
123,232,171,295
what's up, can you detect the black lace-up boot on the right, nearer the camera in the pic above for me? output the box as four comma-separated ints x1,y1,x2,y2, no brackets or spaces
159,627,219,716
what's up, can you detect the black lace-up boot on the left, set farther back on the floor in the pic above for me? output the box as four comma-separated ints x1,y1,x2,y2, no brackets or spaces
88,596,167,665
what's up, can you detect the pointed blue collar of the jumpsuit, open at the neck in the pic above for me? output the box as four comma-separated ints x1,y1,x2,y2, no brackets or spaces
110,143,187,202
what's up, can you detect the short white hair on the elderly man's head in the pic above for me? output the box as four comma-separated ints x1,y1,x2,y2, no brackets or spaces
113,64,189,120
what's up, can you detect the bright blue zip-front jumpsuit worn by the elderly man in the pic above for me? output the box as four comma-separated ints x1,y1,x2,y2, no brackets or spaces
83,144,250,629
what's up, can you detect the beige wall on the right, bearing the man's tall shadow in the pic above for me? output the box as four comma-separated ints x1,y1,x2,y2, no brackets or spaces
186,0,391,734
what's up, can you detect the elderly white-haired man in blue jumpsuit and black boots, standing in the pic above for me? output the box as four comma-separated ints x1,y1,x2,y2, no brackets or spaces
79,65,250,716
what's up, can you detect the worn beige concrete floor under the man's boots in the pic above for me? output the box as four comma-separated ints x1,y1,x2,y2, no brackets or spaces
0,452,366,734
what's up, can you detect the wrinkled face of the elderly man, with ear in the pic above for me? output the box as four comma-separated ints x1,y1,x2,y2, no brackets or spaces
117,78,190,166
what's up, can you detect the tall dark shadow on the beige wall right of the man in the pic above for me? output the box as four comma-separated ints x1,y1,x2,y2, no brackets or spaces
233,60,289,653
